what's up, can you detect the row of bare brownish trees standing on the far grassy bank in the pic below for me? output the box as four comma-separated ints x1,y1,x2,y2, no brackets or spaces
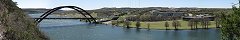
115,17,213,30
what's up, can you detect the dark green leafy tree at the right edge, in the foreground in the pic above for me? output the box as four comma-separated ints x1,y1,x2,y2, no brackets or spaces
220,1,240,40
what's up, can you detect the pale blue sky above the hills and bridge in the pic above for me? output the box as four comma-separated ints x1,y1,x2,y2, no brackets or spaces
13,0,238,10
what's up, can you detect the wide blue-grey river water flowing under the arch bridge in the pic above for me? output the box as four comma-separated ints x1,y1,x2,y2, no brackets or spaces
29,14,220,40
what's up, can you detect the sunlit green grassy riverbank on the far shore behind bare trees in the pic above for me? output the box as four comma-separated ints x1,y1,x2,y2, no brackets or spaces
113,20,217,30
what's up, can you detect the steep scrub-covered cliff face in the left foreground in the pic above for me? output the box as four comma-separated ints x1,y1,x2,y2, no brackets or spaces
0,0,47,40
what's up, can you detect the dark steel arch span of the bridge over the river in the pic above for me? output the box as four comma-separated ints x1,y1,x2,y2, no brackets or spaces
36,6,96,23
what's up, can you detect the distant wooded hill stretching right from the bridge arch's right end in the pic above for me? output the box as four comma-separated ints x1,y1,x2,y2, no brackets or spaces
89,7,231,16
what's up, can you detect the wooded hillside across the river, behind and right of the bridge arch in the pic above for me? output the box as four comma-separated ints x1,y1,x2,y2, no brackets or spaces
51,7,231,18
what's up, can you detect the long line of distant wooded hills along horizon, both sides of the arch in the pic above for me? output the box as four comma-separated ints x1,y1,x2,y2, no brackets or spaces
22,7,231,17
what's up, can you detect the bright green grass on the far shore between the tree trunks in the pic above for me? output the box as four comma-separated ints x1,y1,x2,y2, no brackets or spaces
115,20,216,30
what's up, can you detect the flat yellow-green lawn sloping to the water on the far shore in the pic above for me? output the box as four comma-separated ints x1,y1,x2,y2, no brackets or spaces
120,20,218,29
